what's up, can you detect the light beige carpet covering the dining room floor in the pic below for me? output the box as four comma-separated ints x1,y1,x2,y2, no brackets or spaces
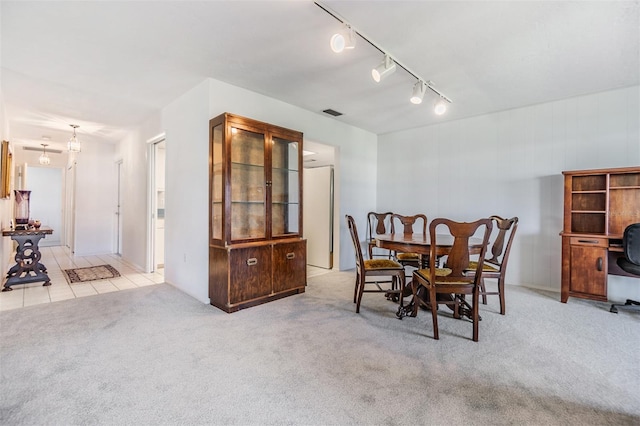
0,271,640,426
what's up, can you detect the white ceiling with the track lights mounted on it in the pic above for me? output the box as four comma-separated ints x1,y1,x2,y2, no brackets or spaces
0,0,640,153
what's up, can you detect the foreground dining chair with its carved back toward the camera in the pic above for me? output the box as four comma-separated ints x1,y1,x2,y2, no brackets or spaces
411,218,493,342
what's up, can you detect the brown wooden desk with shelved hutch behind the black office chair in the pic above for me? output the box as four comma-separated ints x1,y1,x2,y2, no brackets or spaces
560,167,640,303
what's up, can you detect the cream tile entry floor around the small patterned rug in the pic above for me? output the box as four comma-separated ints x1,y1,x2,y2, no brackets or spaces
0,246,164,311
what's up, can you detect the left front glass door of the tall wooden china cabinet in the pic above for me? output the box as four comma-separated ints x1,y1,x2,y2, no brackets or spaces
230,127,266,241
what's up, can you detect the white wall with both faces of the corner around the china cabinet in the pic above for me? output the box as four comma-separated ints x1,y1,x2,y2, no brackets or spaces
162,80,377,303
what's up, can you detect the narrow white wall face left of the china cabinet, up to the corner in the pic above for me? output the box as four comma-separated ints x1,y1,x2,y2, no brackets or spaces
162,81,210,303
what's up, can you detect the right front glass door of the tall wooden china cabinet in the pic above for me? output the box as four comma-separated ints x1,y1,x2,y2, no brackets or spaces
271,136,300,237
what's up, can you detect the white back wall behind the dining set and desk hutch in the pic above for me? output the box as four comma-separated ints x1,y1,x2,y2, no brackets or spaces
377,86,640,300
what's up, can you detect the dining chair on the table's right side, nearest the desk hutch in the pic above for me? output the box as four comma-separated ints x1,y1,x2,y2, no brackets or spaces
468,215,518,315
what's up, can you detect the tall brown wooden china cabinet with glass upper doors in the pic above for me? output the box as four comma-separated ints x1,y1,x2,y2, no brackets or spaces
209,113,307,312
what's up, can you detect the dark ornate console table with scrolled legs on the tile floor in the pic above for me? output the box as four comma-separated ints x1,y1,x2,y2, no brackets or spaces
2,227,53,291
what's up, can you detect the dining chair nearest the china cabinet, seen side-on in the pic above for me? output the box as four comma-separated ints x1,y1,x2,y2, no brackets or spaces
346,215,405,313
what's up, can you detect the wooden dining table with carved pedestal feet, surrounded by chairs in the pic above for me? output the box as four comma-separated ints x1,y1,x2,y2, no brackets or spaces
375,233,482,319
